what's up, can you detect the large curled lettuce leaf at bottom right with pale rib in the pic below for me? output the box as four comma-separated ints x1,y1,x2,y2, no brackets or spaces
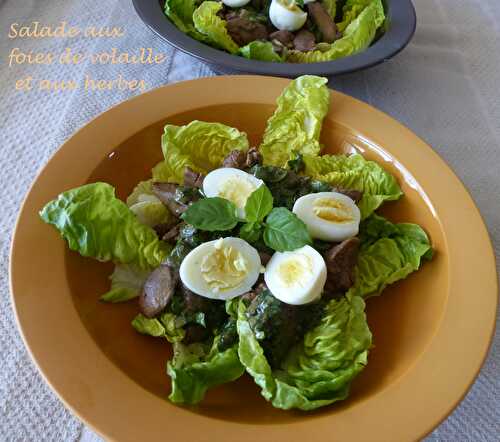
237,296,372,410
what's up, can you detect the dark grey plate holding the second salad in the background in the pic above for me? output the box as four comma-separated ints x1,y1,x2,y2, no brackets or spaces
132,0,417,78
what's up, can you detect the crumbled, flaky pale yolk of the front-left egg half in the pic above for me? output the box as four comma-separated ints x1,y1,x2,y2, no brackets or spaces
200,238,248,293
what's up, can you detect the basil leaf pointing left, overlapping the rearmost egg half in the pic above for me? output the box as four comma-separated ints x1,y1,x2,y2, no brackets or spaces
181,197,238,232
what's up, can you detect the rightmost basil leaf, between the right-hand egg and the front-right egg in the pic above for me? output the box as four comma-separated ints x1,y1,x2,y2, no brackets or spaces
264,207,312,252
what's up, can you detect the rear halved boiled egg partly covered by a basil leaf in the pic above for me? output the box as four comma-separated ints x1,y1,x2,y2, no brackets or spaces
203,167,264,218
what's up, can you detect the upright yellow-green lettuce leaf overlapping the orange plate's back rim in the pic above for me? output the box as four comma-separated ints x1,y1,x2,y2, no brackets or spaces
260,75,330,167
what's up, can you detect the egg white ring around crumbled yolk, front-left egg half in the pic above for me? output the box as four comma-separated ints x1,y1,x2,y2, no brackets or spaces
179,237,261,300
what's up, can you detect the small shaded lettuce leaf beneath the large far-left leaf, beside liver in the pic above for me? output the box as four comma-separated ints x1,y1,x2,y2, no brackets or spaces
101,264,150,302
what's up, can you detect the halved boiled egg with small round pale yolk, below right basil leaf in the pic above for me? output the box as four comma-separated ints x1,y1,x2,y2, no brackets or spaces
264,246,326,305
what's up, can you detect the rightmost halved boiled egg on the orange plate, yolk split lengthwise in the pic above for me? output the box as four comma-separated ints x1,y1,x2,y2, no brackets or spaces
293,192,361,241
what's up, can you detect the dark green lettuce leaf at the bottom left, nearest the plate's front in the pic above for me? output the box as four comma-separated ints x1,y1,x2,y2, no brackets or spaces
167,337,245,404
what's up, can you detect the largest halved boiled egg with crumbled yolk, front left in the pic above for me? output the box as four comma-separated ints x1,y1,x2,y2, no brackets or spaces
179,237,261,300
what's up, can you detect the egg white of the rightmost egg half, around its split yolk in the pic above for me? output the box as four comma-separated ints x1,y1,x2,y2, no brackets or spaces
293,192,361,241
